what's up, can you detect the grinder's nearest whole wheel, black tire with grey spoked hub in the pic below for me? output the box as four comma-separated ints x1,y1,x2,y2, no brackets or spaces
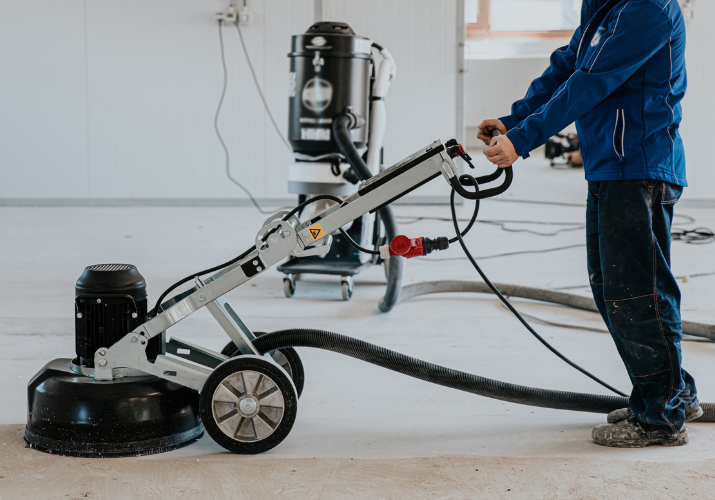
199,356,298,455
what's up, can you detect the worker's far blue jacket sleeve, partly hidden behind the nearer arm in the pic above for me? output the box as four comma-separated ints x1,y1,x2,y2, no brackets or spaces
499,28,581,130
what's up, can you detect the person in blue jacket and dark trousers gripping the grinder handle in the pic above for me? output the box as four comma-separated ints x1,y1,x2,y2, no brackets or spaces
478,0,702,447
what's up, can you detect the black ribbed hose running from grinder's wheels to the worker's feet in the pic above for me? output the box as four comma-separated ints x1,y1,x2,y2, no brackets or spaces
253,328,715,422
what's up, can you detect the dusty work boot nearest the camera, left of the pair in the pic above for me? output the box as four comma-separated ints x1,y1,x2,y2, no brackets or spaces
591,416,690,448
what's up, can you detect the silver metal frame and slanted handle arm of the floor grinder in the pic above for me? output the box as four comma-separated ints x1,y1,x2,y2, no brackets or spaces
93,140,459,392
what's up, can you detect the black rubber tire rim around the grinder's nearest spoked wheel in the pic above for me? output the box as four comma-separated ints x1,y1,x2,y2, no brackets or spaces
199,356,298,455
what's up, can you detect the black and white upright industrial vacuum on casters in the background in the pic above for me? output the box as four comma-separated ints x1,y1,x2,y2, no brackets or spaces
278,22,402,304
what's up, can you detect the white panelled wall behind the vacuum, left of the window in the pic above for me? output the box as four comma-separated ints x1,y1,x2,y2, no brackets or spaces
0,0,457,203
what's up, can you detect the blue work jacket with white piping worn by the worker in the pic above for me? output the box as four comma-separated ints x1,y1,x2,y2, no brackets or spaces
501,0,687,186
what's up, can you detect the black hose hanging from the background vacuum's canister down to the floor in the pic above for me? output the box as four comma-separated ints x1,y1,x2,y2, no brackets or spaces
333,113,404,312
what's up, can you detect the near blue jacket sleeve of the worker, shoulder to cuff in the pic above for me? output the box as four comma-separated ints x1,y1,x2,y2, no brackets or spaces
507,0,672,157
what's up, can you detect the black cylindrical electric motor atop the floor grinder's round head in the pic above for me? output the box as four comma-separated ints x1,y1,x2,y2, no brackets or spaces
75,264,164,367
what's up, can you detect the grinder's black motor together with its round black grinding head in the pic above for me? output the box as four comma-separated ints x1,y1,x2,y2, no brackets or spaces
25,264,203,457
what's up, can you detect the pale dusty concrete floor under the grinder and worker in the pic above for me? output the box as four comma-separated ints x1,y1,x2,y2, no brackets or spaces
0,155,715,500
